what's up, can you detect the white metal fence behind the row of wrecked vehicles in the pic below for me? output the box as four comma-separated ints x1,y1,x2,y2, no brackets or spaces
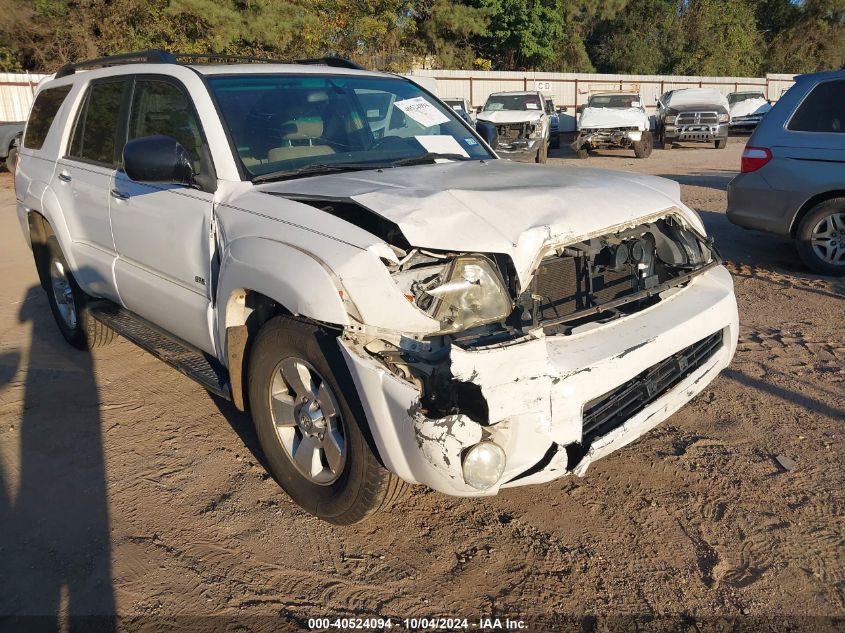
414,70,794,132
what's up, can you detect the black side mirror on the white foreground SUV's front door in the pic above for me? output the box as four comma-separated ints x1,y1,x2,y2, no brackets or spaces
123,136,195,185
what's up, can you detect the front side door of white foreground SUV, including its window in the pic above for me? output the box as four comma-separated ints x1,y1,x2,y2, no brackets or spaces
109,76,215,354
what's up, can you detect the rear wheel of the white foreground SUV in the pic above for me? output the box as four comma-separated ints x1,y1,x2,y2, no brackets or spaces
41,235,115,349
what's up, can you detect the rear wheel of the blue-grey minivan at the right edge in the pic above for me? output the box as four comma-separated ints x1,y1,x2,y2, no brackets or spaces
795,198,845,277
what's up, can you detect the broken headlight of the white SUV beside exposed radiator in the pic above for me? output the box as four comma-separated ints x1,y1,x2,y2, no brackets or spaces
415,255,513,334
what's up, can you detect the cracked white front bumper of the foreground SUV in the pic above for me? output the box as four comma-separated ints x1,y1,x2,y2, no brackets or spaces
341,266,738,496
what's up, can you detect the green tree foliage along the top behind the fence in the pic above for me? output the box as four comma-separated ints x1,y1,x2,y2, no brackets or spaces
0,0,845,75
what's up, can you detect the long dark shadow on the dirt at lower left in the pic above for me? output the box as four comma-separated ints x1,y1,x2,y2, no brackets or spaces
0,288,115,631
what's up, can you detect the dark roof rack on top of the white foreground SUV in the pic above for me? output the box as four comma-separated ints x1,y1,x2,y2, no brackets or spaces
56,48,364,79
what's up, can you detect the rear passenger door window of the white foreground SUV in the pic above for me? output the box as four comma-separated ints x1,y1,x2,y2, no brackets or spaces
68,80,127,166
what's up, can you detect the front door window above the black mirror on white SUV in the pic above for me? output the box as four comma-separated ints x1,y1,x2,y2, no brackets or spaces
128,79,202,173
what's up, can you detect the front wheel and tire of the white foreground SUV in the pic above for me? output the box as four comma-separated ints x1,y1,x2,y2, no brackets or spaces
248,316,409,525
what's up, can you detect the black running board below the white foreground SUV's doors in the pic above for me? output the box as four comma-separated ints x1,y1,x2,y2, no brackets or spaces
88,301,232,400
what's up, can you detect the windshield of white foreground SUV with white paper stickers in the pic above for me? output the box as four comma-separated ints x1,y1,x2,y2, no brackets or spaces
208,75,493,179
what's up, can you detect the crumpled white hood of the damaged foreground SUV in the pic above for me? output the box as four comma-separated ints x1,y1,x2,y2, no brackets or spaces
257,160,692,279
